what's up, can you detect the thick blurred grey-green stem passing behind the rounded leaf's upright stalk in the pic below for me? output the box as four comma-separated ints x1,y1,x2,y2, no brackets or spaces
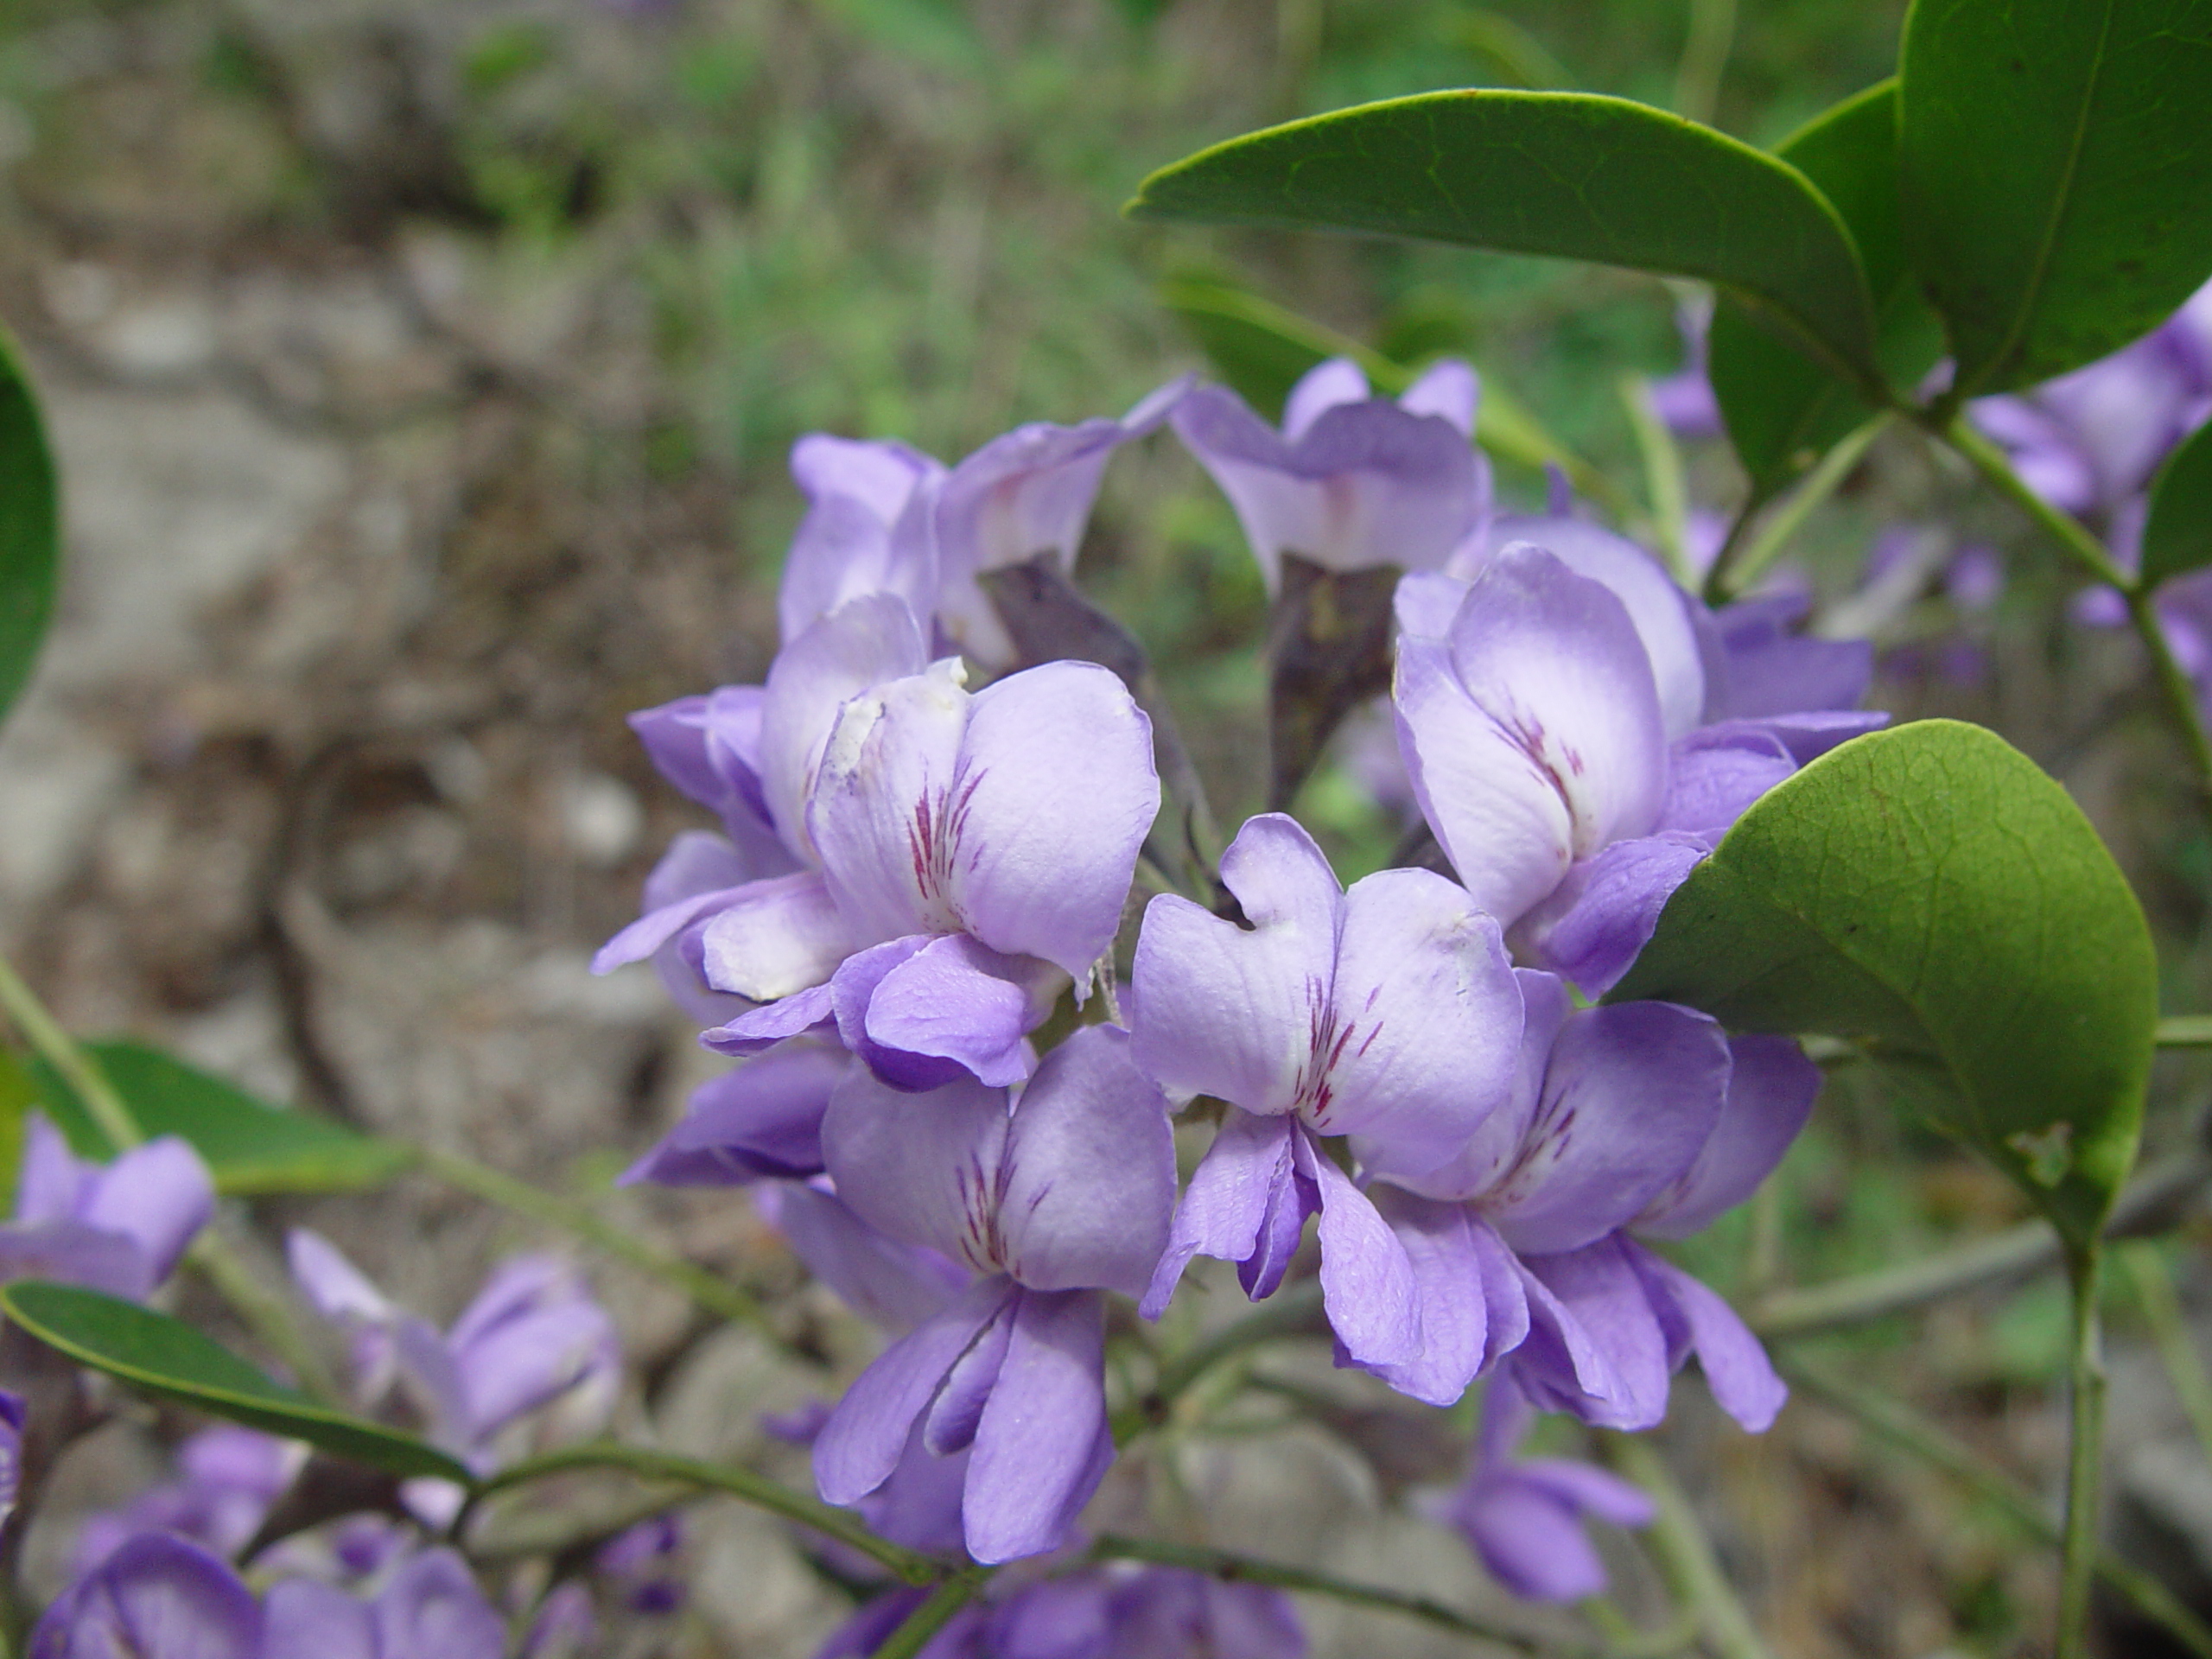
1745,1153,2212,1343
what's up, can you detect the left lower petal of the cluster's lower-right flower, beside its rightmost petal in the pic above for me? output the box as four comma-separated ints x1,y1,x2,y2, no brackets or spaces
1513,1234,1670,1429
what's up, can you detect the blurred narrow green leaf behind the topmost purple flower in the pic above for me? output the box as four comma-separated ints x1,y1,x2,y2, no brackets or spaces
1159,276,1619,505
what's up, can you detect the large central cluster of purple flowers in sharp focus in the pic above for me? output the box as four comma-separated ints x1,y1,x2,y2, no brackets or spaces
600,363,1883,1628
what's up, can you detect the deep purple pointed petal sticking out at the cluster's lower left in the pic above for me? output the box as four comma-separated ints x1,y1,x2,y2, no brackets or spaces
617,1042,852,1185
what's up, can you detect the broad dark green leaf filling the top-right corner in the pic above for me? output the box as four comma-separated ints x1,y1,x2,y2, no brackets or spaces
1897,0,2212,394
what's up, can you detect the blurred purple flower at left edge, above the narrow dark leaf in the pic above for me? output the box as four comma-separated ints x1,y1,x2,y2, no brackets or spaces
0,1115,214,1300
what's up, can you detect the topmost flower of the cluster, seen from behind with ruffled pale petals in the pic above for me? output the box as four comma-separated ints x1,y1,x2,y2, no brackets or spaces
1173,359,1491,593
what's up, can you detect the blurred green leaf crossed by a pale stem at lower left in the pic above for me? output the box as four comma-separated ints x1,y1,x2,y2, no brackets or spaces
38,1042,411,1194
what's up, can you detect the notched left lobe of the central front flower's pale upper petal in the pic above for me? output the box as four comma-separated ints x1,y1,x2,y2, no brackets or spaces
1135,812,1343,1113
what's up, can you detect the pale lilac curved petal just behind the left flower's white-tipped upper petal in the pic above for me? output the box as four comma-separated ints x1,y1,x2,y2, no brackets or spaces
761,593,929,862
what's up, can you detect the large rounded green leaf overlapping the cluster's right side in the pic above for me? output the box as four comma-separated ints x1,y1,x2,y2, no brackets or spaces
1608,721,2159,1245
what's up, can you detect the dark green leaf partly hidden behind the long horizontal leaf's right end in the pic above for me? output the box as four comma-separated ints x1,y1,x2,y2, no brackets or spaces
1710,79,1942,498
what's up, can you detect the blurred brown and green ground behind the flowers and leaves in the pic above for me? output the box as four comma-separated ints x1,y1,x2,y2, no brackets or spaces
0,0,2212,1656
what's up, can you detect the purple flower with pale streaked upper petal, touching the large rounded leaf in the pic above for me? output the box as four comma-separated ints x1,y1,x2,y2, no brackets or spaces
1391,533,1887,991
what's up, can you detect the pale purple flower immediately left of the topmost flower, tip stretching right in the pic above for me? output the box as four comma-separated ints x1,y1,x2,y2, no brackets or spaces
918,376,1190,672
